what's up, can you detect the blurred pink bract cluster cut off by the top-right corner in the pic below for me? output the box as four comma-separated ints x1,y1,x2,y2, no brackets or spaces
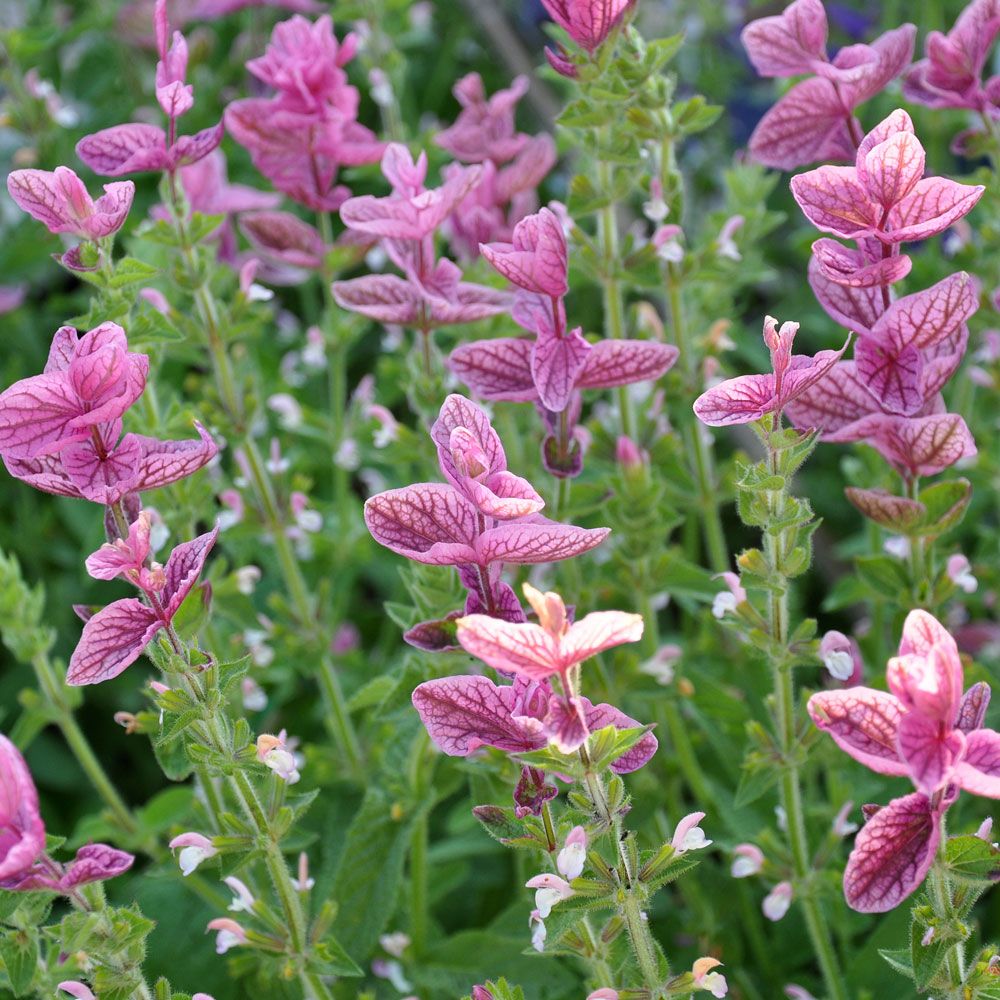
903,0,1000,116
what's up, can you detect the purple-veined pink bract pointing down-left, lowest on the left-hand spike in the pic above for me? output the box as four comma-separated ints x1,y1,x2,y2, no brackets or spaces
66,597,163,686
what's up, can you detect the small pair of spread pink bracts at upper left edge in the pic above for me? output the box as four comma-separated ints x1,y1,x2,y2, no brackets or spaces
7,167,135,240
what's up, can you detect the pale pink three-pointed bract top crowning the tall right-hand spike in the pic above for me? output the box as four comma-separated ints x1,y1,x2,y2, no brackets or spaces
791,110,985,247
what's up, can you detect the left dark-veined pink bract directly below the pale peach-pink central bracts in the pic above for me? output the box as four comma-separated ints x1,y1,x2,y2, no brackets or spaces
413,675,546,757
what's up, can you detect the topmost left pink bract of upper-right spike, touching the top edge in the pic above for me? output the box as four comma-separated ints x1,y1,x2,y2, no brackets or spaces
740,0,827,77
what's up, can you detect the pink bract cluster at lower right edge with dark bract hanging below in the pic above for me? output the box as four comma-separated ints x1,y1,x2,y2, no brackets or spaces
809,611,1000,913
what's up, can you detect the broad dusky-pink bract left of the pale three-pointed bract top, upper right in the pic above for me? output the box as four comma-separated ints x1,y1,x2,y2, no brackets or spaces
750,77,854,170
